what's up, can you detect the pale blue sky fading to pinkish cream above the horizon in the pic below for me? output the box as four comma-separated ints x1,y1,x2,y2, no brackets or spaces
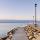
0,0,40,20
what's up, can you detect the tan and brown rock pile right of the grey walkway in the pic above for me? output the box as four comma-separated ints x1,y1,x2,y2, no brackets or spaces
25,25,40,40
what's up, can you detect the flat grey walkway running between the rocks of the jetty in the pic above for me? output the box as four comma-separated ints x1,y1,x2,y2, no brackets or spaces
13,28,28,40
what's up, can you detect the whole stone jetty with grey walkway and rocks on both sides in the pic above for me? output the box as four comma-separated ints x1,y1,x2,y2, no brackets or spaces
0,24,40,40
